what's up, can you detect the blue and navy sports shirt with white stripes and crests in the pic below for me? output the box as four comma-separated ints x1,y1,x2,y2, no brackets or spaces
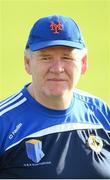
0,86,110,179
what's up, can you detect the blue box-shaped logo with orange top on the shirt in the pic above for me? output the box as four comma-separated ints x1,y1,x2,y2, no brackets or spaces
25,139,45,163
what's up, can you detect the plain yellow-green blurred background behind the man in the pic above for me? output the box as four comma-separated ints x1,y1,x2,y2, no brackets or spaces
0,0,110,105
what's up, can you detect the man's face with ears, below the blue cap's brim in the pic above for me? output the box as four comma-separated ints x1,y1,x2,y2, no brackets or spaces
25,46,86,97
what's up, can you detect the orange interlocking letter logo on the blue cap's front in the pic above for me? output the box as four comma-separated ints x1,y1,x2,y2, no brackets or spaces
50,21,62,34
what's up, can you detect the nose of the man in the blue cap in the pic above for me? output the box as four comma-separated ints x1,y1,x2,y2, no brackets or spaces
50,60,64,73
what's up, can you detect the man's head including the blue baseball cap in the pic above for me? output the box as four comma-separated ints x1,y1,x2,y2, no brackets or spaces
25,15,87,108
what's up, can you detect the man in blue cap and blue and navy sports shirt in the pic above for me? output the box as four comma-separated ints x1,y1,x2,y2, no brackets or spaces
0,15,110,179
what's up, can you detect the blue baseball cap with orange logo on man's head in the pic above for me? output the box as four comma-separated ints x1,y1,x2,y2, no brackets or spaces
26,15,85,51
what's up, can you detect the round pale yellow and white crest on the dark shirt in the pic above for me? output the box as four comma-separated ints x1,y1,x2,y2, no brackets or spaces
87,134,103,153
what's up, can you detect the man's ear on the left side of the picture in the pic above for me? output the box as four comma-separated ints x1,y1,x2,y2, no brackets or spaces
24,55,31,74
